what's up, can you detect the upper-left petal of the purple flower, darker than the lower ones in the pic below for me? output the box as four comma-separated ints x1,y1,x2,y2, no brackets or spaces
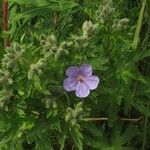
66,66,79,77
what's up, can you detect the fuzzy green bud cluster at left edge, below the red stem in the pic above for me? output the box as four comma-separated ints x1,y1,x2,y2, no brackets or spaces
2,42,25,69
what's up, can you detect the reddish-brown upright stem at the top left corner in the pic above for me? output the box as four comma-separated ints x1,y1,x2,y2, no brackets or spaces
3,0,10,48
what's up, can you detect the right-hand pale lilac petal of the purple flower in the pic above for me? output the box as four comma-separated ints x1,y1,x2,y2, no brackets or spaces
84,76,99,90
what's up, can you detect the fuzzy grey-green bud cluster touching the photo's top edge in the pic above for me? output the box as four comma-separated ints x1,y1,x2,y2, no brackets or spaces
96,0,115,24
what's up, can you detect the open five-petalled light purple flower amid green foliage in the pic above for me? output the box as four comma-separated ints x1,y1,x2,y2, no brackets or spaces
63,64,99,98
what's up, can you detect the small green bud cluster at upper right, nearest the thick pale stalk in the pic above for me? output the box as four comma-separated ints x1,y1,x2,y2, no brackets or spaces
112,18,129,31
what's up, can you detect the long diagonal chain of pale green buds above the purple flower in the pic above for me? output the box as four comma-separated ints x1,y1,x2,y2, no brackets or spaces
41,21,98,60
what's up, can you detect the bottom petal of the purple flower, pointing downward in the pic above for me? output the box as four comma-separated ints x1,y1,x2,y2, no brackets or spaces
76,82,90,98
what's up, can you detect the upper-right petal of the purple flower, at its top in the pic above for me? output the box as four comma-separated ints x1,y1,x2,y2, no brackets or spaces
80,64,92,76
